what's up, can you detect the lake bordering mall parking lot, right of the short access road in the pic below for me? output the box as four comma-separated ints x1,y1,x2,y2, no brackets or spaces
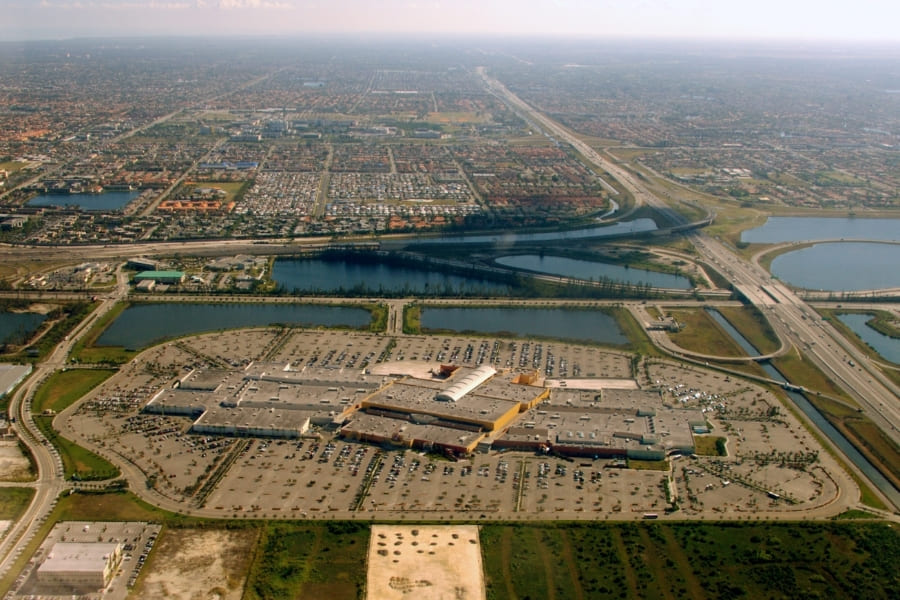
421,306,628,345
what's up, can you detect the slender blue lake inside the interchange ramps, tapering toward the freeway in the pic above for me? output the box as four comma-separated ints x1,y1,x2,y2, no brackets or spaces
495,254,691,290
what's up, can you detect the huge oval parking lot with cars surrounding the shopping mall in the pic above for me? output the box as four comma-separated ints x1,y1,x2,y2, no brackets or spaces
56,328,849,519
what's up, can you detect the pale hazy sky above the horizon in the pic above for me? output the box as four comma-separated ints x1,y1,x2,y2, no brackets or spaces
0,0,900,42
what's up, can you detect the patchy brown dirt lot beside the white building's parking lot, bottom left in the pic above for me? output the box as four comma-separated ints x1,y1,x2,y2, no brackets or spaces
130,529,258,600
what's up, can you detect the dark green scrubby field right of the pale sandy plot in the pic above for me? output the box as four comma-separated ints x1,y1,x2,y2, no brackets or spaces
481,522,900,600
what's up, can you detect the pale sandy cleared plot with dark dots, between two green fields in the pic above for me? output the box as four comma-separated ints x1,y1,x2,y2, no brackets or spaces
366,525,485,600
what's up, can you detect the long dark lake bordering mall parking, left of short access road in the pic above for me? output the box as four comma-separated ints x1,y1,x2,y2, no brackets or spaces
96,302,372,349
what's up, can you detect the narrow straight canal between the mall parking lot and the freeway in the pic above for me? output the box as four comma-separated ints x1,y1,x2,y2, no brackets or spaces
709,310,900,506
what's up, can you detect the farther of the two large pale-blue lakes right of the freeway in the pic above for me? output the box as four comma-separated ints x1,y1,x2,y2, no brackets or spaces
741,217,900,244
